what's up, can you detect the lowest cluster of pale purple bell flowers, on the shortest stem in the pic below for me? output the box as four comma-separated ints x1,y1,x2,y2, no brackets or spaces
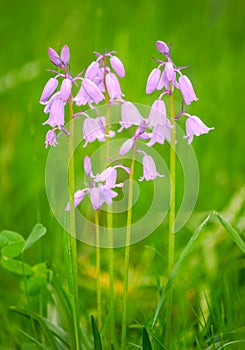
65,156,130,211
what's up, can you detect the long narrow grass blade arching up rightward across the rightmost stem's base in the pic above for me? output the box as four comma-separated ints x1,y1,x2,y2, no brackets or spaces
151,213,213,328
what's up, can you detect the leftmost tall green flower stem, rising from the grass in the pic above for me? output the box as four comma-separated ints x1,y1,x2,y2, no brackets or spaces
66,97,80,350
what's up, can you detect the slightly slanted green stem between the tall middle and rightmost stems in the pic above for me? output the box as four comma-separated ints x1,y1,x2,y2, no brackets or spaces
121,142,136,350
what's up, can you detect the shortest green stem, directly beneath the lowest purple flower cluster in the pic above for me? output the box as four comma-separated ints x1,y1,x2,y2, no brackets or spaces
94,210,102,330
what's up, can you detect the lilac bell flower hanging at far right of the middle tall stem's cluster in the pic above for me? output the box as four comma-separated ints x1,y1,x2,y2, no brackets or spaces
118,102,143,132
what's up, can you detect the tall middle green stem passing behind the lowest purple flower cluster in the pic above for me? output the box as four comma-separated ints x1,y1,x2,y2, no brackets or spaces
103,58,116,346
